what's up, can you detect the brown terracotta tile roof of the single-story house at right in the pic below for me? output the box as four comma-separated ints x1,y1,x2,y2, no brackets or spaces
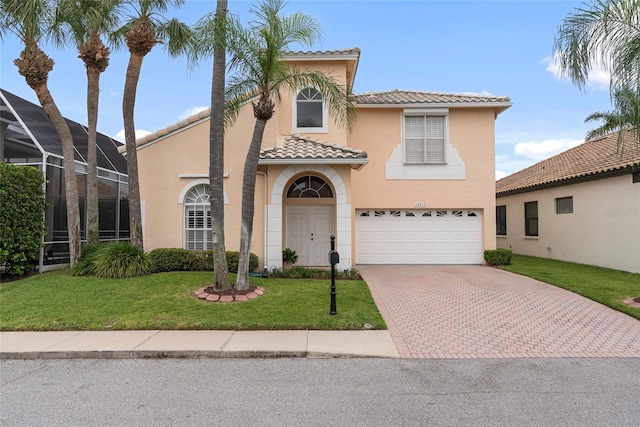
496,130,640,196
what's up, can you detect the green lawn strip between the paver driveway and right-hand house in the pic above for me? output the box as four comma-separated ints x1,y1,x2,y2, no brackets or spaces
500,254,640,319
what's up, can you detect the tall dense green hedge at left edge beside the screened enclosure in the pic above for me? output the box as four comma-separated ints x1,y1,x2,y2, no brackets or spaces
0,162,47,276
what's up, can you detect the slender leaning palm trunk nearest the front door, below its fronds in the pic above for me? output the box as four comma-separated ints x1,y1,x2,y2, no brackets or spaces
235,119,267,291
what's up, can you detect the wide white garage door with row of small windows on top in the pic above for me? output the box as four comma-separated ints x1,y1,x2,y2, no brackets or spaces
356,209,483,264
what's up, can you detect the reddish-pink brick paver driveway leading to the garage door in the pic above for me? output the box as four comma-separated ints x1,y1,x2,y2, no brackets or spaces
357,265,640,358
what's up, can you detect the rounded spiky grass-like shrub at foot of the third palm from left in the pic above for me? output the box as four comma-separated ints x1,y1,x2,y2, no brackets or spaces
93,242,153,279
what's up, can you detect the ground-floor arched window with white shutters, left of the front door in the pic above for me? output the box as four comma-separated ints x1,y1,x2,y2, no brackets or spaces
184,184,213,250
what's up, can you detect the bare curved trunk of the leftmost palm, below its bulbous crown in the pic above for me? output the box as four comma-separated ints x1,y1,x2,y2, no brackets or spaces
33,83,80,267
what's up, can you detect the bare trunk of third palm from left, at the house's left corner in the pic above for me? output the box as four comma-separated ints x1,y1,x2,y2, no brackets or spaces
122,53,144,249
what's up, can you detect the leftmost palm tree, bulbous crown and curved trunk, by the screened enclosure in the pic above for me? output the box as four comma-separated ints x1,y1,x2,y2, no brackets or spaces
0,0,80,267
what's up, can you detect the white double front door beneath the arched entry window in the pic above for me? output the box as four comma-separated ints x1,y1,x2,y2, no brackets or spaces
285,205,334,266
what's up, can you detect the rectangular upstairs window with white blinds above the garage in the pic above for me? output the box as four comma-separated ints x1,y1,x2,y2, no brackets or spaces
404,116,445,164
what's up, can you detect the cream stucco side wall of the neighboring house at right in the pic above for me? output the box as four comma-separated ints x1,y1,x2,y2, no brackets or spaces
496,175,640,273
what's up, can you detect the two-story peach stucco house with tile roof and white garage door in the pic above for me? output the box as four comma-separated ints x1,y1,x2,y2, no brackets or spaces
132,49,512,269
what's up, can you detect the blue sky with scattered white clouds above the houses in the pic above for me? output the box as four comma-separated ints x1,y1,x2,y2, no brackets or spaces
0,0,611,178
